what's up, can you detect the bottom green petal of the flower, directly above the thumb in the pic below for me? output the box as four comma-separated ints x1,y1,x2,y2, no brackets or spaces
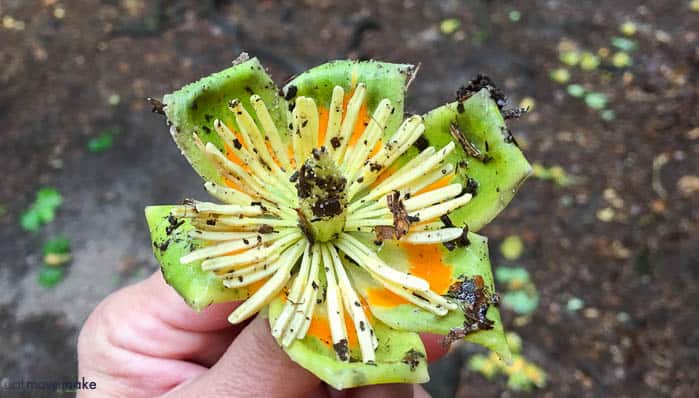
269,297,429,390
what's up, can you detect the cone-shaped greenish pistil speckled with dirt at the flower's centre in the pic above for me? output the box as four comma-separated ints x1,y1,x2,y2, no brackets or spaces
292,147,347,242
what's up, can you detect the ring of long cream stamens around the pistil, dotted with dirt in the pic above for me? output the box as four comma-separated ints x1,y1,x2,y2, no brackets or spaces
172,84,471,363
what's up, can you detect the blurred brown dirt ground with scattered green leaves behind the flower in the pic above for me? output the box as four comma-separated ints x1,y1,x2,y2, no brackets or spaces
0,0,699,397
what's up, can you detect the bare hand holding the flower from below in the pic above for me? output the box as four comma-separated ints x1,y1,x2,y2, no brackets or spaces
78,272,446,398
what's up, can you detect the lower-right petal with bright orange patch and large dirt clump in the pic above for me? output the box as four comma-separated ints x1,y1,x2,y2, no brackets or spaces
347,233,511,361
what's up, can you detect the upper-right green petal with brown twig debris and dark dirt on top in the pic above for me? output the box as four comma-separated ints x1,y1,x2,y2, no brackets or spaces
422,89,532,232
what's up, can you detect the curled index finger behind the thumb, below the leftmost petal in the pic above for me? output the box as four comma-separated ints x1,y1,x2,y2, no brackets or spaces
82,272,242,367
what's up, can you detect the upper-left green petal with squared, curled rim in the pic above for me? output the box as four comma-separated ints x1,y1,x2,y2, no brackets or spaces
163,58,288,183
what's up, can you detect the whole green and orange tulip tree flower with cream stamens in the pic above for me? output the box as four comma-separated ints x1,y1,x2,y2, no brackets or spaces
146,54,531,389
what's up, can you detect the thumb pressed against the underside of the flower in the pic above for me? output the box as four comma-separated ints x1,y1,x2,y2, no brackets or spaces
166,316,320,398
